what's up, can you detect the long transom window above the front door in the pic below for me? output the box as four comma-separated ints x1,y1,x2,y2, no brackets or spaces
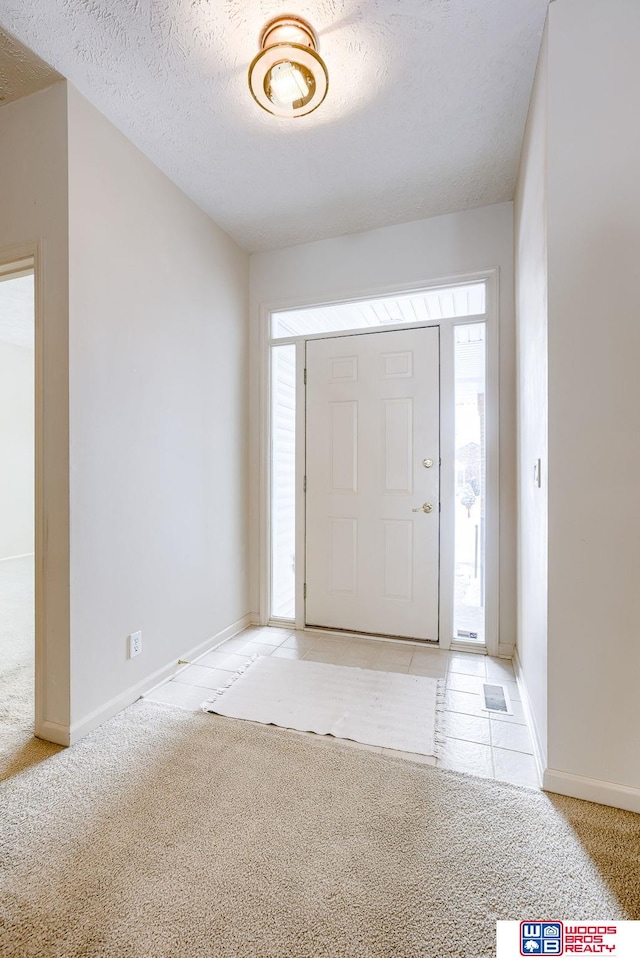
271,283,486,339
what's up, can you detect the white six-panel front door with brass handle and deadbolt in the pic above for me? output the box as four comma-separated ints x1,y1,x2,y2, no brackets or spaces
306,327,440,641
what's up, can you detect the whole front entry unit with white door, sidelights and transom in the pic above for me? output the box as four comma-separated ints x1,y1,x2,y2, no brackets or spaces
261,272,498,654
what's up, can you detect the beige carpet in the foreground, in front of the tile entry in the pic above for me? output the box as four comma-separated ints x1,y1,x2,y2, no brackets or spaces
0,702,640,958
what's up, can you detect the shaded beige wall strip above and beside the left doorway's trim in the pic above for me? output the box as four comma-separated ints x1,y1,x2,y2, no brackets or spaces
0,82,69,737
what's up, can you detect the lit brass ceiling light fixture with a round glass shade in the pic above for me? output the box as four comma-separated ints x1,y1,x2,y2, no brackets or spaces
249,14,329,116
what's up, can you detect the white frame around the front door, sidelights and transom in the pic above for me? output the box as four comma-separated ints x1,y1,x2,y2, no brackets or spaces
259,268,500,655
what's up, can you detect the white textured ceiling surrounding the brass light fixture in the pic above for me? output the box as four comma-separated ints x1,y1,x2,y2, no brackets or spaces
0,0,547,250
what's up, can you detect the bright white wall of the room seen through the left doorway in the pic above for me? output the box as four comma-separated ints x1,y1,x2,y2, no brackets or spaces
0,340,34,559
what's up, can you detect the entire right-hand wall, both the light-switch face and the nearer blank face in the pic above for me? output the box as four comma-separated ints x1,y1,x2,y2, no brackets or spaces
516,0,640,811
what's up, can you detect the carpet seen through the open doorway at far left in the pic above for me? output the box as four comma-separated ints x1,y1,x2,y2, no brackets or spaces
0,556,60,781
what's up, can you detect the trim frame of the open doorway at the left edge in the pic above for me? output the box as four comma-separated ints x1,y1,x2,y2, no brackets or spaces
0,242,46,735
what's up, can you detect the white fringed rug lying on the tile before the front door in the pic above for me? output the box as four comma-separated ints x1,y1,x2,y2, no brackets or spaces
205,655,444,755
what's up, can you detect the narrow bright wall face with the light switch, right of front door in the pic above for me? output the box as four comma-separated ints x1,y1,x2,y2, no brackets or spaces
514,24,549,766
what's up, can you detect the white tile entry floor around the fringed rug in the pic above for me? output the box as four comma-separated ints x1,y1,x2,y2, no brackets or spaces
145,628,539,787
